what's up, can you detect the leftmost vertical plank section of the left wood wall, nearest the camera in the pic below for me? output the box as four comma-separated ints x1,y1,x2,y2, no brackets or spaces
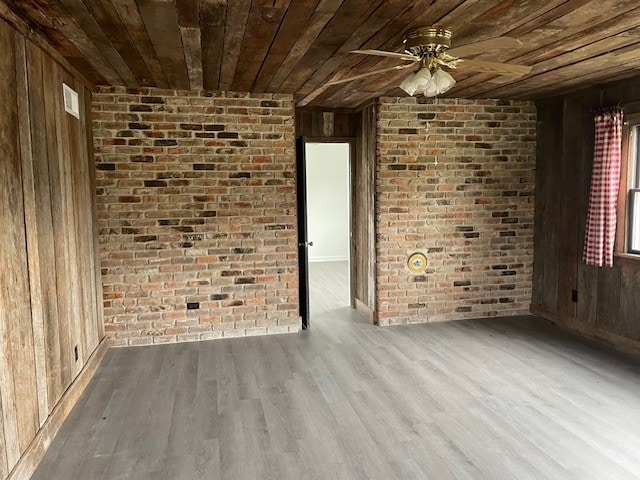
0,22,39,470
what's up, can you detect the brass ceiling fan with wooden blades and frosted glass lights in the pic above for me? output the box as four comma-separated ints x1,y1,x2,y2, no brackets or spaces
326,26,531,97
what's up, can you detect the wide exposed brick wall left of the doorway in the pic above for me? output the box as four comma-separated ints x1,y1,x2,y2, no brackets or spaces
93,87,300,345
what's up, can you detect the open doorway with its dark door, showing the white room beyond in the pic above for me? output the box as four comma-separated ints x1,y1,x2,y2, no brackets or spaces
298,139,352,328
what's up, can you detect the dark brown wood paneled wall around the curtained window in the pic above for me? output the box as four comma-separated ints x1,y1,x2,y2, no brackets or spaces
531,79,640,349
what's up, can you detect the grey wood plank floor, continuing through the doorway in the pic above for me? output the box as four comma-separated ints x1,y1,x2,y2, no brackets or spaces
28,263,640,480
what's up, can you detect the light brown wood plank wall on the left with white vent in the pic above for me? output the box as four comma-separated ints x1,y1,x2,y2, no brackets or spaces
0,16,104,479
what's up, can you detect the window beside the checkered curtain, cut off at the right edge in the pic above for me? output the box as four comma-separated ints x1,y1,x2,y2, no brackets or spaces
618,120,640,255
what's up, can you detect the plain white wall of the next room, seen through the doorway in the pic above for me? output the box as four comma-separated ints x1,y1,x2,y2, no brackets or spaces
306,143,349,262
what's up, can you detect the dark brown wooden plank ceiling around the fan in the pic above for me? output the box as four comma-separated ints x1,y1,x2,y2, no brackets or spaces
0,0,640,107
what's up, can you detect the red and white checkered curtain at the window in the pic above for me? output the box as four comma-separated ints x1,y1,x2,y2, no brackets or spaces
582,108,622,267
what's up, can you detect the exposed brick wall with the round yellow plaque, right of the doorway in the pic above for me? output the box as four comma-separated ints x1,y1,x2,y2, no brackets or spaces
376,98,536,325
